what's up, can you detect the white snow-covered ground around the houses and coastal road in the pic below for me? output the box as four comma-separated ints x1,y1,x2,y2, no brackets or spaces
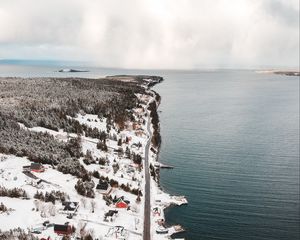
0,90,186,240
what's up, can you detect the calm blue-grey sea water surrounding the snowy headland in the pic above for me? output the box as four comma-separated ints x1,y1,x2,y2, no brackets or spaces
0,65,300,240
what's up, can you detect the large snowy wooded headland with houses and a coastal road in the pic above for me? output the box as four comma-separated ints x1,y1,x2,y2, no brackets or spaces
0,75,187,240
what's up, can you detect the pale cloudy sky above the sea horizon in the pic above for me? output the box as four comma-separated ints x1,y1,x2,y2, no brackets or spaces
0,0,299,69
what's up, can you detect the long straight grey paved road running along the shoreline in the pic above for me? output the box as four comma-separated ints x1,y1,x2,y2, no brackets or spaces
143,109,152,240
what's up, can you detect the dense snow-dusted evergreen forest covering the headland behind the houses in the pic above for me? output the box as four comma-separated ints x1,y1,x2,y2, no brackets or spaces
0,76,150,171
